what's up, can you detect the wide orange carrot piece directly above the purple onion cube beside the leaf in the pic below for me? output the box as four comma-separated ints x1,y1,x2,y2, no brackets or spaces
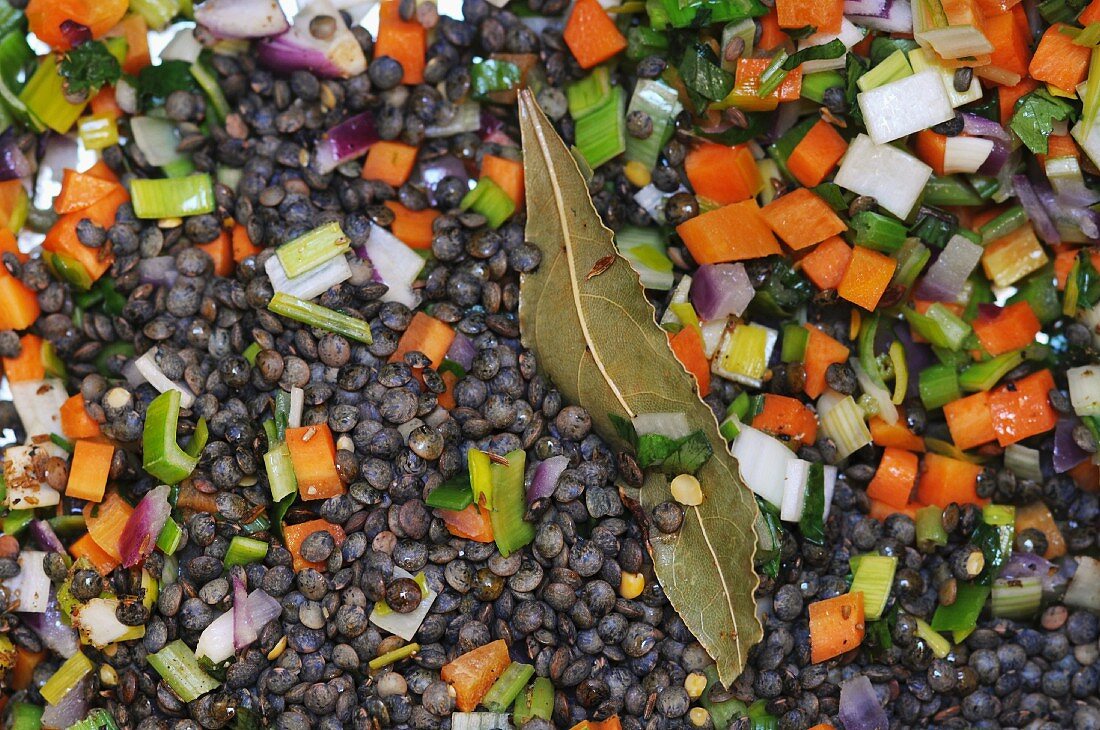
677,199,781,264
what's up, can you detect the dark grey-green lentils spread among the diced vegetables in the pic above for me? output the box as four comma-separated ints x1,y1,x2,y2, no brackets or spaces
0,0,1100,730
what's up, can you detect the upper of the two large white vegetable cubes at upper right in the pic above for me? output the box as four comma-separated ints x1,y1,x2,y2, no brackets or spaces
856,70,955,144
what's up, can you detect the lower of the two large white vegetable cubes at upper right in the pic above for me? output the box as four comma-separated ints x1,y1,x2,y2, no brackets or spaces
834,134,932,218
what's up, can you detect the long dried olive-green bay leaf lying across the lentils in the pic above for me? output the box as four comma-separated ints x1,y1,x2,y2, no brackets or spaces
519,91,762,685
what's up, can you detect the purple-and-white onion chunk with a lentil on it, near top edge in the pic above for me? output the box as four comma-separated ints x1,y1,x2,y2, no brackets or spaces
256,0,366,78
